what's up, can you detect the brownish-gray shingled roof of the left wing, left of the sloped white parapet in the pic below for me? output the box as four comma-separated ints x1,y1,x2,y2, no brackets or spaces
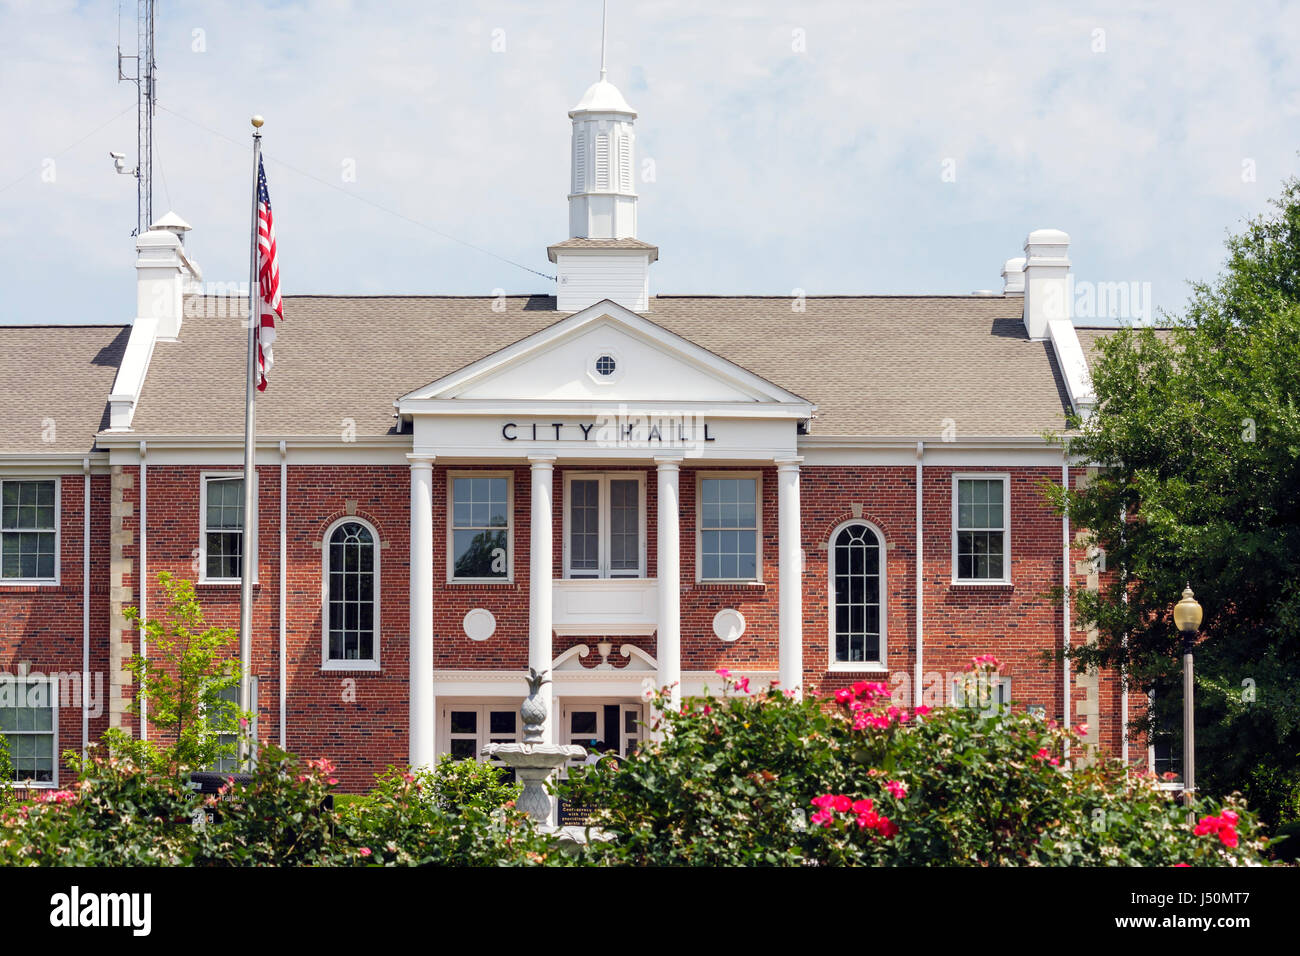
0,325,131,454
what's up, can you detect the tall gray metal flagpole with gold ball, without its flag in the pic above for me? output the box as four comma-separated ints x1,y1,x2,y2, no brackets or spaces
238,116,263,770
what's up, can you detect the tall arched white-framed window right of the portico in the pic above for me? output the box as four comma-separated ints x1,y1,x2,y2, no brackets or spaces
828,519,889,670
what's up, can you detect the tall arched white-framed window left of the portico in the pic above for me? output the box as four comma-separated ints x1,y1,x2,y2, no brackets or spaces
321,515,380,670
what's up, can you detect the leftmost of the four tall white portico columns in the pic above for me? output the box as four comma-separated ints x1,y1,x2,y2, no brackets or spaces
407,455,437,767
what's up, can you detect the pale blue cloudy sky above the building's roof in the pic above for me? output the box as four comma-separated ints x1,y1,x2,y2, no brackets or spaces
0,0,1300,324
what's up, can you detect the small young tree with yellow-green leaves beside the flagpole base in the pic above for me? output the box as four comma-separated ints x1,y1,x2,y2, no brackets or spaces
120,571,247,770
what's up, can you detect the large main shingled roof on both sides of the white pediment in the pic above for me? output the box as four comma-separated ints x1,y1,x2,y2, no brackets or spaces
124,295,1067,437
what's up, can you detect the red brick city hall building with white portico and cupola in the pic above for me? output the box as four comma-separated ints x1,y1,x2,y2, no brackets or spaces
0,70,1147,788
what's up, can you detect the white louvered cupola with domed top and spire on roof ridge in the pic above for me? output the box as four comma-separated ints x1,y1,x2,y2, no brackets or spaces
546,5,659,312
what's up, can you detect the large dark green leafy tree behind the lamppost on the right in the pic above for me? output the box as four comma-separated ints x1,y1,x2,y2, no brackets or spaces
1049,179,1300,823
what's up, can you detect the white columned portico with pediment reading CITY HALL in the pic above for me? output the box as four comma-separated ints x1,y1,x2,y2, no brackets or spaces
397,300,813,765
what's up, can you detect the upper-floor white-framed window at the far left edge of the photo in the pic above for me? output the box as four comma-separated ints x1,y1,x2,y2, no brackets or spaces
0,477,60,584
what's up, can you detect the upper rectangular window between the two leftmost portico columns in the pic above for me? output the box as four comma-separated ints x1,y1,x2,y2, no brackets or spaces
447,471,515,583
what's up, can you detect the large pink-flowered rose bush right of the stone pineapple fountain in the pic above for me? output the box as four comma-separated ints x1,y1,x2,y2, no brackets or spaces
562,656,1268,866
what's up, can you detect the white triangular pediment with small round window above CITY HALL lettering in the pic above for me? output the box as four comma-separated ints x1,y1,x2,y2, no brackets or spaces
398,299,811,407
